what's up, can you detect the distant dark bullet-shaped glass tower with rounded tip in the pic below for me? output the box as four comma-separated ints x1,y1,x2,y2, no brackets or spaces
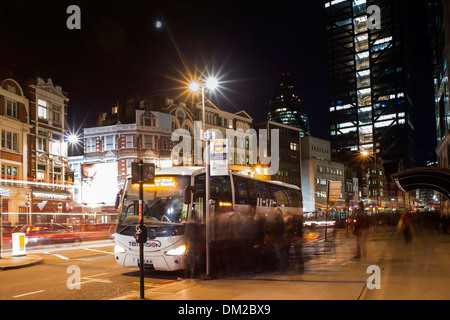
267,73,310,137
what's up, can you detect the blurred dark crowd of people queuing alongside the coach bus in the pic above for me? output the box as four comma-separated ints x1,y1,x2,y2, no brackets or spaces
186,210,301,277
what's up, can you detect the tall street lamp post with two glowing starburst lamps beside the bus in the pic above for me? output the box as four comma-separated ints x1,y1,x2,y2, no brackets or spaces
189,77,217,279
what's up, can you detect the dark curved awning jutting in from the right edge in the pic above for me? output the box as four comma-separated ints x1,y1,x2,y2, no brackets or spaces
392,167,450,200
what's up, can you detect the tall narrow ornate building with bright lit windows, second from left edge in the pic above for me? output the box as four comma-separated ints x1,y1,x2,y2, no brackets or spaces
24,77,72,222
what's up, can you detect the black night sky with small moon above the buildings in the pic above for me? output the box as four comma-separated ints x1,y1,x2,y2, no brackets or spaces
0,0,436,165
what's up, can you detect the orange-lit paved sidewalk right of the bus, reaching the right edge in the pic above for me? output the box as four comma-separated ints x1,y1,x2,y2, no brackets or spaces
117,227,450,300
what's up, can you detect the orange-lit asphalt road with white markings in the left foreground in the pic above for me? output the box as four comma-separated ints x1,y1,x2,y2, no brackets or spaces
0,228,332,300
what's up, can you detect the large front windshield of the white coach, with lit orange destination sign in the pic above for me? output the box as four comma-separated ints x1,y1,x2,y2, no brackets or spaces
118,176,190,225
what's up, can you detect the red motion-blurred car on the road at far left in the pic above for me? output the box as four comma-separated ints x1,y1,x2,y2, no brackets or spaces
11,223,82,245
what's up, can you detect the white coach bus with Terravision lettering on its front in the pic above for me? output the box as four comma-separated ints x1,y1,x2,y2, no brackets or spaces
114,167,303,271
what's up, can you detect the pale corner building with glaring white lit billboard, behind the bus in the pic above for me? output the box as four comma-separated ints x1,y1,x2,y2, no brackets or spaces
69,101,172,212
